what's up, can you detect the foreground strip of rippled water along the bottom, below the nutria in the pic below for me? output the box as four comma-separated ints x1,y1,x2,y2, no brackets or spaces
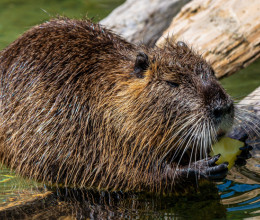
0,157,260,219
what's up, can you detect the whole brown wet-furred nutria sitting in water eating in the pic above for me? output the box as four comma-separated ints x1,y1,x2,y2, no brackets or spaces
0,18,252,191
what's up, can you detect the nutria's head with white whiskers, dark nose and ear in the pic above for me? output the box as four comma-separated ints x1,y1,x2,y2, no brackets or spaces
109,42,234,168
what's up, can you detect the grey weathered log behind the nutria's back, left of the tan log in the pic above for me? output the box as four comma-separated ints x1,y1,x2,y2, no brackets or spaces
100,0,190,45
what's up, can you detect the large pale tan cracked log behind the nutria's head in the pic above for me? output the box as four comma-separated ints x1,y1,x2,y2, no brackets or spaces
156,0,260,77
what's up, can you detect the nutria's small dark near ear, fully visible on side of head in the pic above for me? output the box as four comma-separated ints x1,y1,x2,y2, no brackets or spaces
133,52,149,78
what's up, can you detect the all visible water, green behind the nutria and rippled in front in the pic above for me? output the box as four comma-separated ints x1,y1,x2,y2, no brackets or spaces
0,0,260,219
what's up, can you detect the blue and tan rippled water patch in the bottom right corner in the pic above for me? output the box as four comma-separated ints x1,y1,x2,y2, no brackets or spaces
218,158,260,218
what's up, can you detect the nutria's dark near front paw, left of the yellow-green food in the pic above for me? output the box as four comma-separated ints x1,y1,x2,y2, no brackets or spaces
180,154,228,181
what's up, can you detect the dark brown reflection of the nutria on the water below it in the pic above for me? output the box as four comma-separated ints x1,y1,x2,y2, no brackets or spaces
0,187,226,219
